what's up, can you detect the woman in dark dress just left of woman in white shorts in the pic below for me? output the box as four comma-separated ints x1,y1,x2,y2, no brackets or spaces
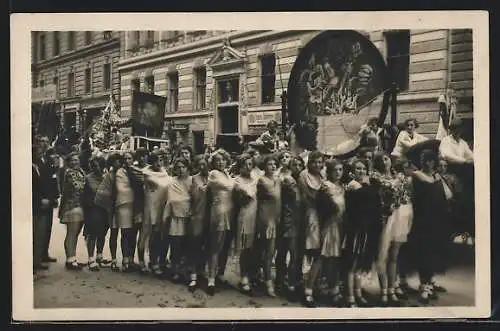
342,159,382,307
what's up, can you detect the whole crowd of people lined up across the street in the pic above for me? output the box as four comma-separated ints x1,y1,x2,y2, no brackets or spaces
32,119,473,307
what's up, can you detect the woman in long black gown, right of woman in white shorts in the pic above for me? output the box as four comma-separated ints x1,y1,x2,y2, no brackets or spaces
409,150,452,303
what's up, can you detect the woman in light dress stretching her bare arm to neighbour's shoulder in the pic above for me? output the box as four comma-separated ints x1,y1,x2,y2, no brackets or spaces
138,154,171,276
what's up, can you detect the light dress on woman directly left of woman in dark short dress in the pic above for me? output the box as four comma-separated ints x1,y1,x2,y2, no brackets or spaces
321,181,345,257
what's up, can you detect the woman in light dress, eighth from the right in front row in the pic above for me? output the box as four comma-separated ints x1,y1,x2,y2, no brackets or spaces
234,154,257,294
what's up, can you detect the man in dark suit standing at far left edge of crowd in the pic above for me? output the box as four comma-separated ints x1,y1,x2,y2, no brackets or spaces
38,148,59,262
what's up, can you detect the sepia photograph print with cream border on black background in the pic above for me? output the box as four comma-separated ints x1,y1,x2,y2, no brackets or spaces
11,12,490,320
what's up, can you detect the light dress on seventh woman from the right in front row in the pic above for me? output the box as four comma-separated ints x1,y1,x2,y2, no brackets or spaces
257,176,281,239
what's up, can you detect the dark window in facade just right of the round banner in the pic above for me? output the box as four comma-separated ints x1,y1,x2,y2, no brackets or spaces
385,30,410,91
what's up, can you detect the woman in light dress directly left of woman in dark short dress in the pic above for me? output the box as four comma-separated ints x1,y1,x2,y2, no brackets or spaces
305,159,345,307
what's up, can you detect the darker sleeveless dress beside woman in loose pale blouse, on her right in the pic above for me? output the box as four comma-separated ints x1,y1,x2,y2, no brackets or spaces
188,174,208,236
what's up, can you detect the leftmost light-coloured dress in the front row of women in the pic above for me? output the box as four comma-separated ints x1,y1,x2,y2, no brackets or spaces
112,168,134,229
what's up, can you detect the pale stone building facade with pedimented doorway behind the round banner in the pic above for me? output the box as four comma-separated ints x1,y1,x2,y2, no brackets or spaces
118,30,473,152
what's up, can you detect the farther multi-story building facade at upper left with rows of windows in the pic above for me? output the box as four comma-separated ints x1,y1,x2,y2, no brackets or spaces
31,31,120,133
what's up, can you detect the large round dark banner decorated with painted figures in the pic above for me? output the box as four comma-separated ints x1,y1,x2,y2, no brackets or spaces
287,30,389,155
